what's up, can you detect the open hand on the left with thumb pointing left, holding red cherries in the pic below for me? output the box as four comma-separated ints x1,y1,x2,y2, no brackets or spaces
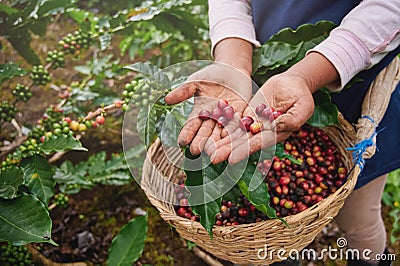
165,63,251,155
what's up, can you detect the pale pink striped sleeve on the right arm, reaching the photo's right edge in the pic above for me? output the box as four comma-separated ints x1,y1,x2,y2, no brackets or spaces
309,0,400,90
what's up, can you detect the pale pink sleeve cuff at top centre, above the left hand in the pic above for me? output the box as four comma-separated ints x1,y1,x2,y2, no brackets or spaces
208,0,260,54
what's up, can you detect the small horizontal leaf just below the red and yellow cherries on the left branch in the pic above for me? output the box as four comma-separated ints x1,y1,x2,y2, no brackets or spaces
42,135,87,154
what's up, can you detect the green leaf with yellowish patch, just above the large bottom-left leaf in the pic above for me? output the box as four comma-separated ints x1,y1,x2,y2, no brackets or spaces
21,155,56,205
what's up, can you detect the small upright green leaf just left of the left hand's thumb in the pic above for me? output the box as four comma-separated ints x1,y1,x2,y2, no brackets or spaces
136,106,157,147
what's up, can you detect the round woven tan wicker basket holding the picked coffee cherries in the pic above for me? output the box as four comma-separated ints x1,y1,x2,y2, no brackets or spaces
141,57,398,265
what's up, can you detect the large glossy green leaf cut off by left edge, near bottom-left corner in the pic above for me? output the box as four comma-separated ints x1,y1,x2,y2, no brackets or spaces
0,195,57,245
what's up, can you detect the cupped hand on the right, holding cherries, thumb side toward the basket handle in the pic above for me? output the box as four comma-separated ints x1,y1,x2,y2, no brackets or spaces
212,72,314,164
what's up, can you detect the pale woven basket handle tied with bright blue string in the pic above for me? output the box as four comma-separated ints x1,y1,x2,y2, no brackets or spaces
349,56,400,169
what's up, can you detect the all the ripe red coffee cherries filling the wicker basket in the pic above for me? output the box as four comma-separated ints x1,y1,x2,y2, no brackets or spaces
175,119,348,225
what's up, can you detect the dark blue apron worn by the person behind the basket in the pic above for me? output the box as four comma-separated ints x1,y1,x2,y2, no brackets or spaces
252,0,400,188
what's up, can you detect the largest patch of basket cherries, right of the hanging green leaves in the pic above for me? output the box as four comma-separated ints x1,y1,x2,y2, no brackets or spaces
258,125,347,217
